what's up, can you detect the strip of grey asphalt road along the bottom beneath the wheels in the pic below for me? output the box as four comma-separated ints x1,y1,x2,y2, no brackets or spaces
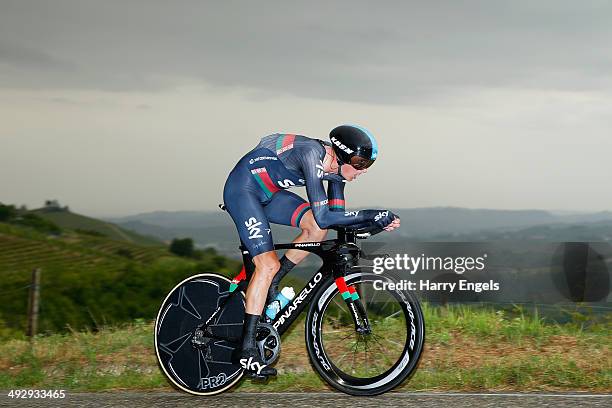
0,392,612,408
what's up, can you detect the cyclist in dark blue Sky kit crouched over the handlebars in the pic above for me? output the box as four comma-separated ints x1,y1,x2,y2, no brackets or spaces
223,125,400,377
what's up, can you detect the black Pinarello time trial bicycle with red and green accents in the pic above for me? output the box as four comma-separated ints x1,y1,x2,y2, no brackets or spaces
155,223,425,395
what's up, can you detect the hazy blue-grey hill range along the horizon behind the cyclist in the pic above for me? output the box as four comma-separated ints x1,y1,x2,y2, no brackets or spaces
109,207,612,257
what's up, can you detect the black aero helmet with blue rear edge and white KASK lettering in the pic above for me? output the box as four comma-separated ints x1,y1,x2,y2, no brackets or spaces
329,125,378,170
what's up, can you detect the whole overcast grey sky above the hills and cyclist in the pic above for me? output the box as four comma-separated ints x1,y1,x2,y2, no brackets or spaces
0,0,612,216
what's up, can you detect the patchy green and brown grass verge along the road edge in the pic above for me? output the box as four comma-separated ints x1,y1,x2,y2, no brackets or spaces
0,305,612,392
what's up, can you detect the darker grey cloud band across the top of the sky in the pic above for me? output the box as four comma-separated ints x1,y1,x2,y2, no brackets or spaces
0,1,612,104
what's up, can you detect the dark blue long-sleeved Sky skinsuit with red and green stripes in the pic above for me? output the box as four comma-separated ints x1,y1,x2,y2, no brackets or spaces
223,133,383,256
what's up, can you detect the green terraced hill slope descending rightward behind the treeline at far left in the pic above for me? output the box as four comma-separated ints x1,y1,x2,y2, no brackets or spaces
30,208,162,246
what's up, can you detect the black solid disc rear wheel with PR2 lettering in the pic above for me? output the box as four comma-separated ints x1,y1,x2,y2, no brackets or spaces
154,273,245,395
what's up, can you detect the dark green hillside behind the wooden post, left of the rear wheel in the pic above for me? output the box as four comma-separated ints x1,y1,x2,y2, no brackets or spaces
0,222,238,337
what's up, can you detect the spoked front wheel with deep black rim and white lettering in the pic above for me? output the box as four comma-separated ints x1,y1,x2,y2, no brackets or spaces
306,272,425,395
